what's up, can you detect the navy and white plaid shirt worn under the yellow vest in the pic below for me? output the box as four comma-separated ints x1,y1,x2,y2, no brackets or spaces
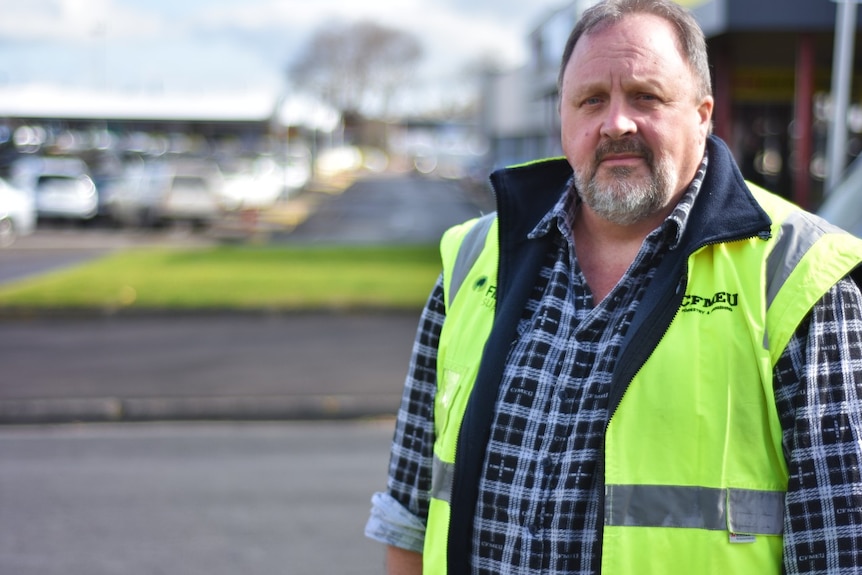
366,158,862,575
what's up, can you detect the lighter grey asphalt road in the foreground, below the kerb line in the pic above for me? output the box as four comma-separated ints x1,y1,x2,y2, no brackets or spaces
0,420,392,575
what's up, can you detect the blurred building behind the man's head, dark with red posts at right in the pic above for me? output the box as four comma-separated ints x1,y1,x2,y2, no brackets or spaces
482,0,862,212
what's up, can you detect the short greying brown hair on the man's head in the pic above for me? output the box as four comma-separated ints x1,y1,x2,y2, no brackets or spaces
557,0,712,98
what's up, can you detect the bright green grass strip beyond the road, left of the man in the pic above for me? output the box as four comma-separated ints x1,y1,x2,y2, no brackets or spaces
0,245,440,310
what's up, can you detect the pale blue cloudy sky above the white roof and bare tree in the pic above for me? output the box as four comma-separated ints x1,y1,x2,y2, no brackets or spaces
0,0,571,112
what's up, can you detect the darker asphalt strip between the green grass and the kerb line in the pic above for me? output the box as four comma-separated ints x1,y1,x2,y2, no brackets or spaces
0,312,417,423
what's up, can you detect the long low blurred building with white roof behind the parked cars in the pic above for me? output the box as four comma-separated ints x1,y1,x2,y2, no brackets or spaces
0,86,341,179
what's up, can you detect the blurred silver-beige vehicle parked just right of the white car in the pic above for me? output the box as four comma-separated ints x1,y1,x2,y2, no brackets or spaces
106,159,225,231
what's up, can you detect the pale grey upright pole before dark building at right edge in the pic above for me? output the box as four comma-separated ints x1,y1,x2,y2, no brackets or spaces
824,0,858,195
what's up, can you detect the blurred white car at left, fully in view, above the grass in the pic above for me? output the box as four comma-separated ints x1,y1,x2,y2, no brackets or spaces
12,157,99,220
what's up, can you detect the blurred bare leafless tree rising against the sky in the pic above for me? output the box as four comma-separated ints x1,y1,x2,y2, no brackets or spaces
288,22,422,118
